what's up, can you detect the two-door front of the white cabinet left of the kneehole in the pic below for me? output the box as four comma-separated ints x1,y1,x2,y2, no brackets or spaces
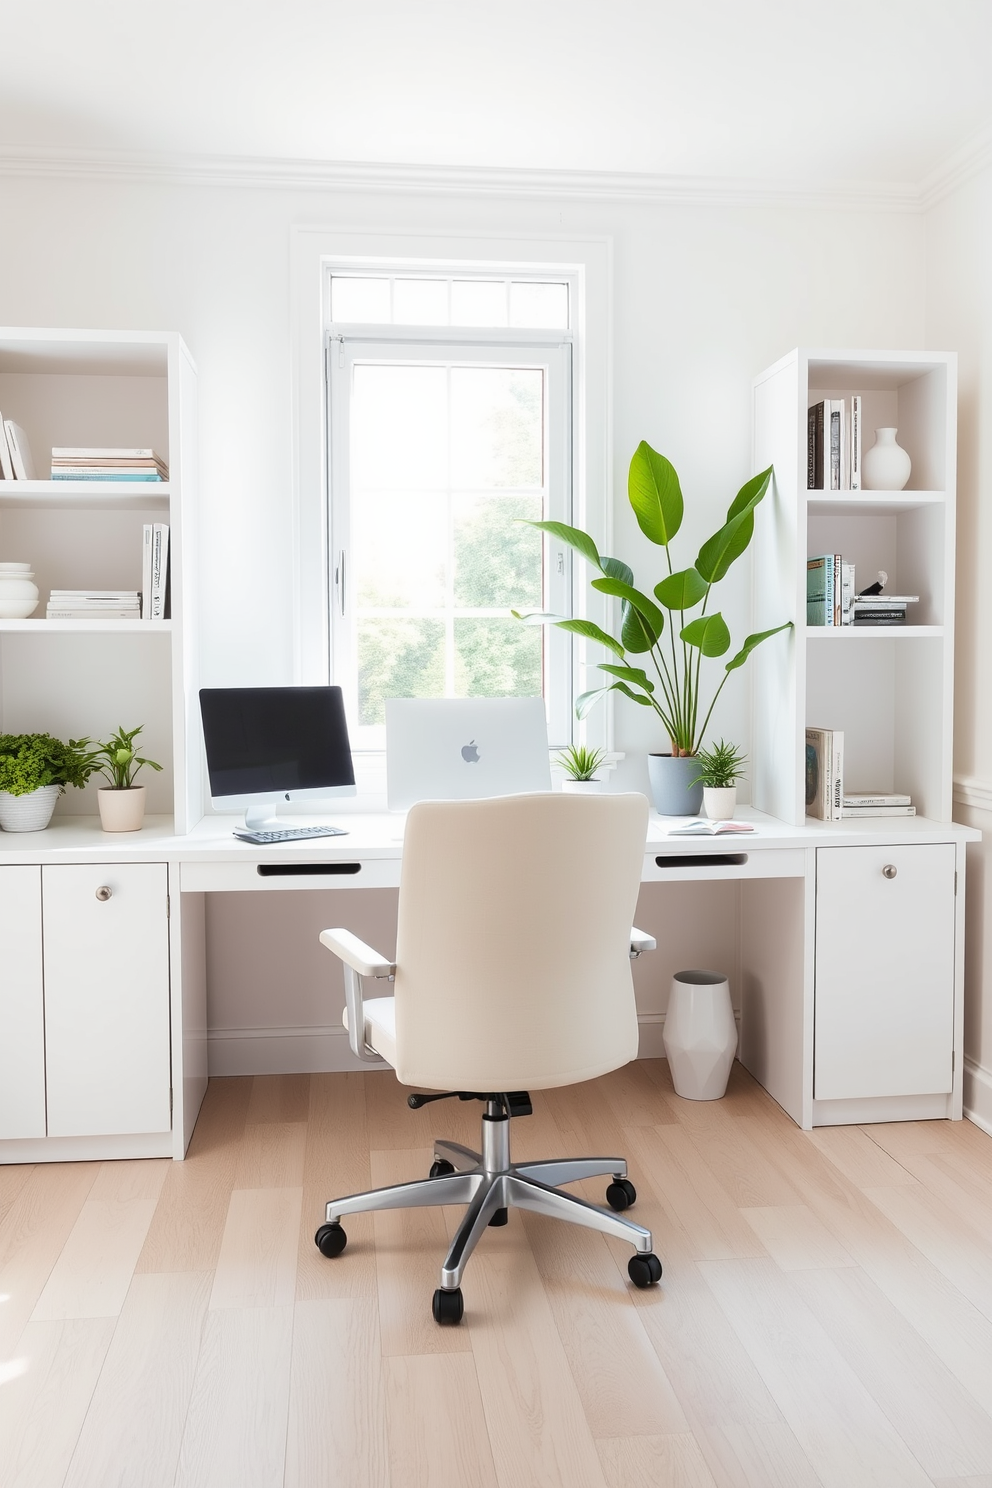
0,863,171,1136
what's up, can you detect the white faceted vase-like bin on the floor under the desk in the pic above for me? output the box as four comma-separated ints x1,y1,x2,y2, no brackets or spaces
663,970,738,1101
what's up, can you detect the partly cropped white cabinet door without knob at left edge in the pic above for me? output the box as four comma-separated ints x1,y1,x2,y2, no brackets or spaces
0,865,45,1138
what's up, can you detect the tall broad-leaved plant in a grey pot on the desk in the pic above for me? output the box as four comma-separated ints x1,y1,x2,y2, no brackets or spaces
512,440,793,815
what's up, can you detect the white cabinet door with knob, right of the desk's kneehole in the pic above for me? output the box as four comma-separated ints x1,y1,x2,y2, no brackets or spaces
814,842,955,1100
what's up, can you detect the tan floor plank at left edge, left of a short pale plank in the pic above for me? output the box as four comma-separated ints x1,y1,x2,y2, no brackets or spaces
0,1162,98,1360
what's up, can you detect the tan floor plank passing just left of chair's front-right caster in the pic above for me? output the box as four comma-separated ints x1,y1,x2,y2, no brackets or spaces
525,1214,689,1437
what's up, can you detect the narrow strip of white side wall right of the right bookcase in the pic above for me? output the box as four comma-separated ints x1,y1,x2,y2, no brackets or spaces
927,156,992,1129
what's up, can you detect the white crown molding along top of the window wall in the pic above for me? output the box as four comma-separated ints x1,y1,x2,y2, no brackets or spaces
0,147,921,213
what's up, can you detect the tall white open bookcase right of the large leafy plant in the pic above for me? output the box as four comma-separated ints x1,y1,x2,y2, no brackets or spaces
753,348,956,824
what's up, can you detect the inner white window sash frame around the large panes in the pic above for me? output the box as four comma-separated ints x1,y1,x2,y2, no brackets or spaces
326,323,576,748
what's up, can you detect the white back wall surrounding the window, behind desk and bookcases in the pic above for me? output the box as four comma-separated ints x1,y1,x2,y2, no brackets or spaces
0,168,928,1065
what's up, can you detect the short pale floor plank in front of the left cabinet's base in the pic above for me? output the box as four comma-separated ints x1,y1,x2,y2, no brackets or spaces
31,1198,155,1321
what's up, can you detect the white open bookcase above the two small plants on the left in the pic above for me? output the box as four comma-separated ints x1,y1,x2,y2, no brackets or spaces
0,327,202,832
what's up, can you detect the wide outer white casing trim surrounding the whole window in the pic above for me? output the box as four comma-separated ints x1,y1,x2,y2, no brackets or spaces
290,232,614,767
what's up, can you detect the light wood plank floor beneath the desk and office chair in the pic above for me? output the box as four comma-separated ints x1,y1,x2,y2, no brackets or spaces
0,1061,992,1488
